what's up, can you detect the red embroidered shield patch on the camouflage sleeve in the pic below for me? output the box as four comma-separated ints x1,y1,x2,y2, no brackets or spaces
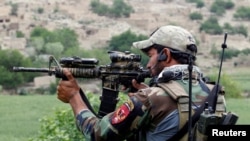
111,100,134,124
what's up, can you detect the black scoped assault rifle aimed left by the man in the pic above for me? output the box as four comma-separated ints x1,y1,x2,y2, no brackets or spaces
12,51,150,117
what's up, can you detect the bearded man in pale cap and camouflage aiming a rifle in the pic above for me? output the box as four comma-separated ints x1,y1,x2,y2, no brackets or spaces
57,25,225,141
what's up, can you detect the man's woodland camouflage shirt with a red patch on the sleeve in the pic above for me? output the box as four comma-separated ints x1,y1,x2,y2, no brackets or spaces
77,65,207,141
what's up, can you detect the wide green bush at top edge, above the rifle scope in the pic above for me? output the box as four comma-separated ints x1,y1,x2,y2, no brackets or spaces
90,0,133,18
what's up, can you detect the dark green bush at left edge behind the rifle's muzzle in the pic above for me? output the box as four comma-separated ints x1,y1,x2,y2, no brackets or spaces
0,50,34,89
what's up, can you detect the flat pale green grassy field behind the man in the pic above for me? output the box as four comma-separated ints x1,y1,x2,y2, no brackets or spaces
0,95,250,141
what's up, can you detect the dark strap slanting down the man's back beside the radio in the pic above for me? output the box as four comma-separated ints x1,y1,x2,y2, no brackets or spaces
168,82,221,141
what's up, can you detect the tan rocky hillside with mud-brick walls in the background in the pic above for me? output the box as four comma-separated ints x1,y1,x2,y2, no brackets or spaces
0,0,250,70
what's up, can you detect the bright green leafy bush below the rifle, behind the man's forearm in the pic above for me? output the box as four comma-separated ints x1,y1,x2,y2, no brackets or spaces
29,92,131,141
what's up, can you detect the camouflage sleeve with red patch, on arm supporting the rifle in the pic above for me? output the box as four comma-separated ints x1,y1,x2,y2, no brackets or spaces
76,97,145,141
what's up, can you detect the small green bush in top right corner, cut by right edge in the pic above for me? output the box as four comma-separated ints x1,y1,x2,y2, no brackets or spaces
234,6,250,20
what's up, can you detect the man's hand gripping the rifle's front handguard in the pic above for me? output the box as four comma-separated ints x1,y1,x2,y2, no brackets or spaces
57,69,80,103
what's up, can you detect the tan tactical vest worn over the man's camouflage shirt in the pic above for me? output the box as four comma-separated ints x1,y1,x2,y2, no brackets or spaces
157,81,225,141
